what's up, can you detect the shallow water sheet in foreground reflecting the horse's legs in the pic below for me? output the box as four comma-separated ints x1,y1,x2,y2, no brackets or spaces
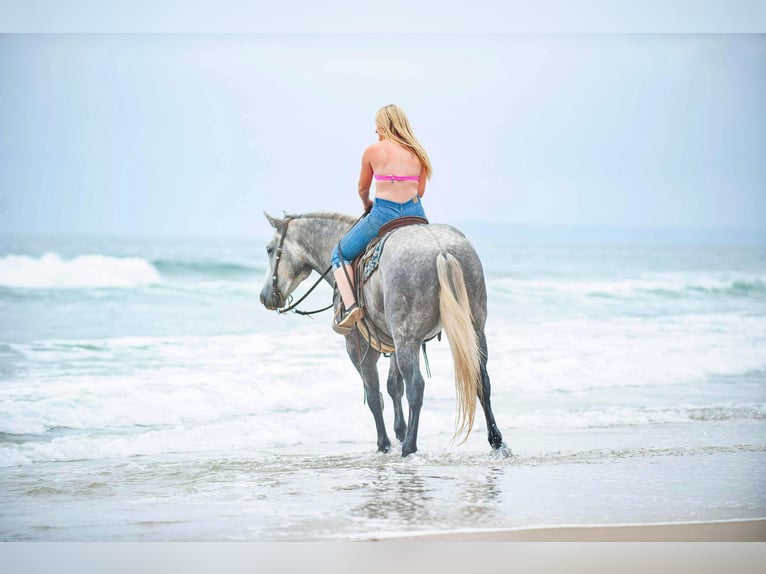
0,438,766,540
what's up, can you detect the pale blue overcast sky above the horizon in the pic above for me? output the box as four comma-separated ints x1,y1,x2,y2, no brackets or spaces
0,33,766,235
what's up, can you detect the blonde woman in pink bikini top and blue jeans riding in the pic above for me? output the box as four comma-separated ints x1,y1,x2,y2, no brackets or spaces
332,104,432,327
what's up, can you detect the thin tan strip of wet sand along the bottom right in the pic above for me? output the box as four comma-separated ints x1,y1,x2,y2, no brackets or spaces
368,519,766,542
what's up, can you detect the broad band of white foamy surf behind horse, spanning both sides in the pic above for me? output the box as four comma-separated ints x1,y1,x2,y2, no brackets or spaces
0,314,766,466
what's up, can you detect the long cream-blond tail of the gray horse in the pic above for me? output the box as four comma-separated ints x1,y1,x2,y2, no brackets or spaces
436,253,481,444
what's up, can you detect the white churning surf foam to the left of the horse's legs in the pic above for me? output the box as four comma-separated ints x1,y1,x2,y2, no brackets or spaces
0,332,368,434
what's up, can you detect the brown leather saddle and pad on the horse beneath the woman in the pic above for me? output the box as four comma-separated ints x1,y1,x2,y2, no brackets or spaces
333,216,428,355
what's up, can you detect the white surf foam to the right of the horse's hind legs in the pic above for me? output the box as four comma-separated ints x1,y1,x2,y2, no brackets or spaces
484,314,766,394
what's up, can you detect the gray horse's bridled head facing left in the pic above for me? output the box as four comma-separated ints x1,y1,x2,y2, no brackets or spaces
261,213,311,310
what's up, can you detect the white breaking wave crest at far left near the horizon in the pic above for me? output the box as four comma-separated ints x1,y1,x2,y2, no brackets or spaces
0,253,161,289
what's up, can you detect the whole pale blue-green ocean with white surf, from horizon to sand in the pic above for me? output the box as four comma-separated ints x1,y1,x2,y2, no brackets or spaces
0,230,766,540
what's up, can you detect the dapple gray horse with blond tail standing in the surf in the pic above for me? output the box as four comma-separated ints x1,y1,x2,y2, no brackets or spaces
261,213,508,456
